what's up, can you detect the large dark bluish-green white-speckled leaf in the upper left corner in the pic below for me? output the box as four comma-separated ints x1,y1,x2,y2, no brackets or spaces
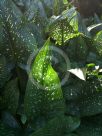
0,0,37,64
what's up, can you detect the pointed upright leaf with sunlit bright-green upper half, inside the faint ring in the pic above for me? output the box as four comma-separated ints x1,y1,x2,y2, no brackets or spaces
24,39,64,118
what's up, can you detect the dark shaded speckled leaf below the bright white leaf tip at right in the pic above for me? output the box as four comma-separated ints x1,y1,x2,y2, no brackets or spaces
65,77,102,117
